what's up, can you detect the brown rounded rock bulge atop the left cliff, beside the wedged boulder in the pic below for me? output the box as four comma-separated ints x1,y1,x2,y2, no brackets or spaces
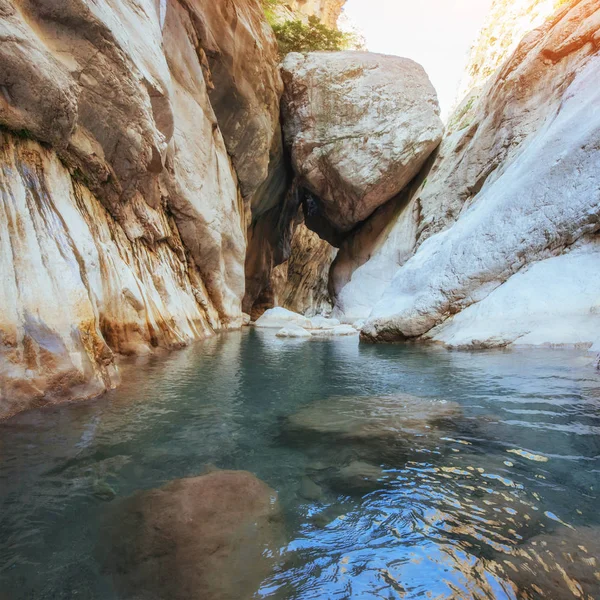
191,0,283,198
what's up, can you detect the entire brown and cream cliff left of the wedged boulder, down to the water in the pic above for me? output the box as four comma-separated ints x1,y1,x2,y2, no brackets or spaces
0,0,282,414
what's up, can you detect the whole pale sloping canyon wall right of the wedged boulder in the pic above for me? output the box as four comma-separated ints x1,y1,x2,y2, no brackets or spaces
336,0,600,346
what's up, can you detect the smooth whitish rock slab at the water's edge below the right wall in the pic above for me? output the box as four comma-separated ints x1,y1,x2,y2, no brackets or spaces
429,240,600,348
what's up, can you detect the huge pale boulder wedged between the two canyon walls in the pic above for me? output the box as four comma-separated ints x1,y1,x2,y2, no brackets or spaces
282,52,443,243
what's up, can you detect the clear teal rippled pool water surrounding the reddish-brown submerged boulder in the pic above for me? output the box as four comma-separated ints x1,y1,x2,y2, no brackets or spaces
0,330,600,600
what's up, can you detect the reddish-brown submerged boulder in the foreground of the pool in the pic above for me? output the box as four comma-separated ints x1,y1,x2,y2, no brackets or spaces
107,471,283,600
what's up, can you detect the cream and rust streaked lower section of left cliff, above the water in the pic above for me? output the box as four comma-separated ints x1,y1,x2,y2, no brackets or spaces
0,135,212,414
